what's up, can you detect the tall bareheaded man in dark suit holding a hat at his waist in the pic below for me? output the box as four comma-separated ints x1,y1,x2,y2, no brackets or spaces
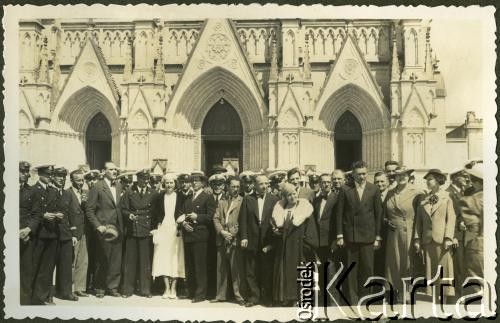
85,162,123,298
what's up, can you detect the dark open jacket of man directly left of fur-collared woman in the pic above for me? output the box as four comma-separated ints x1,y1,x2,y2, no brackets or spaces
239,193,279,251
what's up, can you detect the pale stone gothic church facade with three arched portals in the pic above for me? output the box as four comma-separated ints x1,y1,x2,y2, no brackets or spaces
19,19,482,173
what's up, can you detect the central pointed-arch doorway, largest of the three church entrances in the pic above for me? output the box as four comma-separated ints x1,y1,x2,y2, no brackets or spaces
201,99,243,176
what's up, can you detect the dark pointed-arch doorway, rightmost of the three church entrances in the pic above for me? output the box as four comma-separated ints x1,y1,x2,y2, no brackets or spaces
335,111,363,171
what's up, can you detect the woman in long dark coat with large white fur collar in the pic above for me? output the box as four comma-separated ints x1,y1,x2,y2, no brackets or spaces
272,183,313,306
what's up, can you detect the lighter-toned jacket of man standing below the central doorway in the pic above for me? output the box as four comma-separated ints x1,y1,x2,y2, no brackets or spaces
214,195,243,246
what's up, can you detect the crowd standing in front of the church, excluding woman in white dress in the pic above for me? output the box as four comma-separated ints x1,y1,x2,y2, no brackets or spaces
19,160,483,307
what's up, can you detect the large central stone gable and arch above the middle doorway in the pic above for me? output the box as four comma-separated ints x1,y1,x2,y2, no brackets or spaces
167,19,267,130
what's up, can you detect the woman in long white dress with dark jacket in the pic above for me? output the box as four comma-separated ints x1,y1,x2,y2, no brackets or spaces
151,174,186,298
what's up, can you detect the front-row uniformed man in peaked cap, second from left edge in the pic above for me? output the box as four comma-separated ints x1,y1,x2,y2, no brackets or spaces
32,165,65,305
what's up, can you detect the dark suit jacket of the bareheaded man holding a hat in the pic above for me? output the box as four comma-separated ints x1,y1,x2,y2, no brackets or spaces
85,180,123,232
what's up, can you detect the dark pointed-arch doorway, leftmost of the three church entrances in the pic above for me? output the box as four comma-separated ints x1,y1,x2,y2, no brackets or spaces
85,112,111,170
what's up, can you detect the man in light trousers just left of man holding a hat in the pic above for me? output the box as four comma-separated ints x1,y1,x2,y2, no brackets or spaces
67,170,88,297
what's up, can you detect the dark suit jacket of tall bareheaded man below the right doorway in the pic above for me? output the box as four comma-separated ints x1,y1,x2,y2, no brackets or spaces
336,182,383,243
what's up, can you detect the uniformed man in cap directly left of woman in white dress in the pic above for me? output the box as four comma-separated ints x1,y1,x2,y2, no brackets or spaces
121,169,158,298
